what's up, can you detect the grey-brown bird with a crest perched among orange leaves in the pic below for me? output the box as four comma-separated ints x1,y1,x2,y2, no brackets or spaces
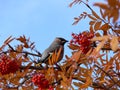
38,37,68,64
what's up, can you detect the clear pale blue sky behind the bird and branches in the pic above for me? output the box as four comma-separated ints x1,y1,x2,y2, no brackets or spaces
0,0,101,54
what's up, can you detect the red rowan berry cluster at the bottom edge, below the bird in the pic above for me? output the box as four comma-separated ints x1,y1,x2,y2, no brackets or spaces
32,73,53,90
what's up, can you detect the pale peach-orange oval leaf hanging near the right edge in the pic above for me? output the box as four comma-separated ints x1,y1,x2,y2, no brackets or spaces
110,36,119,51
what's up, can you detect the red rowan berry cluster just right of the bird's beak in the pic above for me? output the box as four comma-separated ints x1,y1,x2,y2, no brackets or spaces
70,31,94,54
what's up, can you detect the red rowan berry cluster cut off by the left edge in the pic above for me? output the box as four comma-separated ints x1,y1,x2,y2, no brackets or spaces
0,55,20,75
